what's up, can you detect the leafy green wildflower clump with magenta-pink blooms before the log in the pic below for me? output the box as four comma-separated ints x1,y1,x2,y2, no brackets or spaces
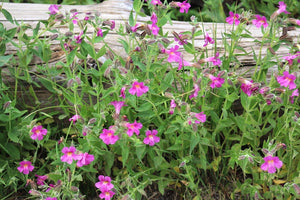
0,0,300,199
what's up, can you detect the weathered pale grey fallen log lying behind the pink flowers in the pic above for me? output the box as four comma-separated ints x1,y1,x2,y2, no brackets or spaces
0,0,300,109
